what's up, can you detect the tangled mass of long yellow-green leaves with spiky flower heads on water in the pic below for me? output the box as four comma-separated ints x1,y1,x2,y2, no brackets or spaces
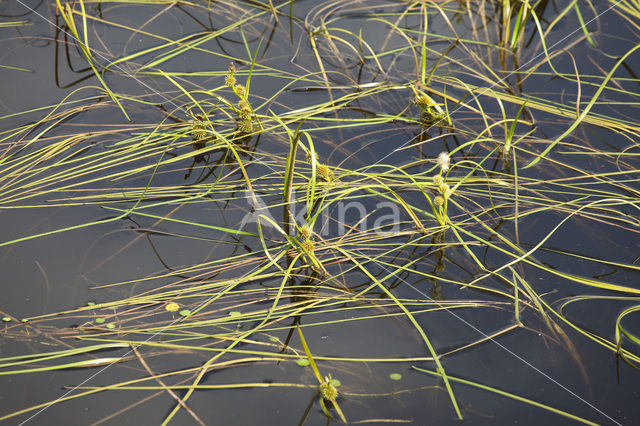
0,1,640,424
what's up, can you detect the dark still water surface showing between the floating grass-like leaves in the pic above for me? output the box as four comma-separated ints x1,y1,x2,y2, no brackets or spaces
0,1,640,425
